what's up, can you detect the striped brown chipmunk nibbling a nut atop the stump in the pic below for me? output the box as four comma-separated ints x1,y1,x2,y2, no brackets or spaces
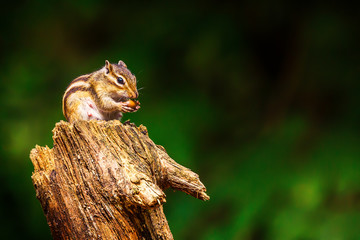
62,60,140,123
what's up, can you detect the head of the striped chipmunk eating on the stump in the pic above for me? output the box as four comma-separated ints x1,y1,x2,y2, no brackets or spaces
104,60,139,102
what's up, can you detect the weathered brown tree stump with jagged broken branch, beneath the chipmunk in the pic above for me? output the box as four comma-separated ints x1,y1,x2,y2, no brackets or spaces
30,120,209,239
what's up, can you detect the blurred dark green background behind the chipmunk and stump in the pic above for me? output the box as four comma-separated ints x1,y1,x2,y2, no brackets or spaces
0,0,360,240
